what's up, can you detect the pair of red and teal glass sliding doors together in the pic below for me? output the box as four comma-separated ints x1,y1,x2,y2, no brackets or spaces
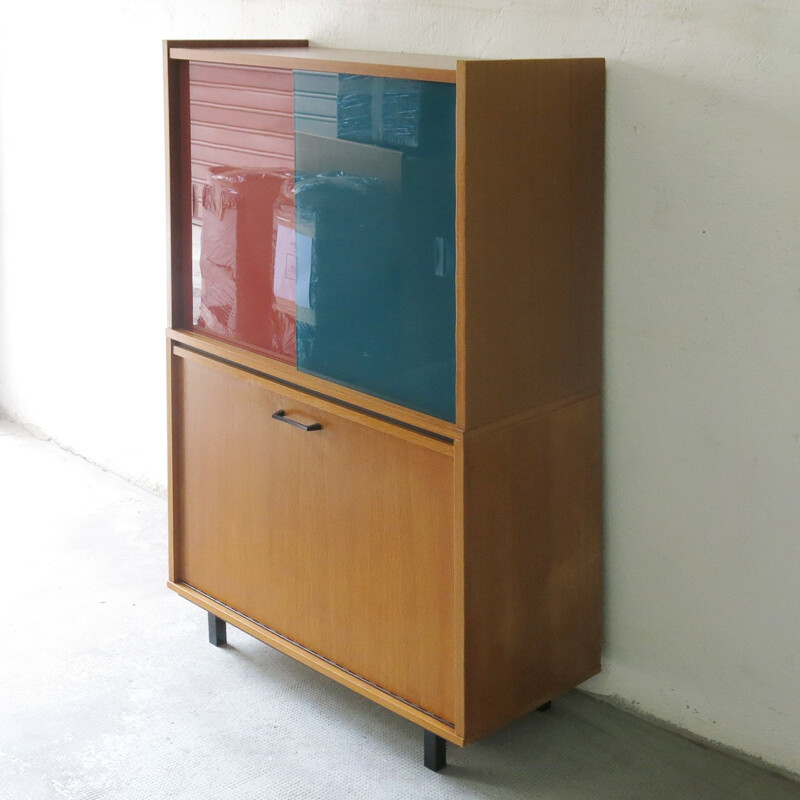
182,54,456,421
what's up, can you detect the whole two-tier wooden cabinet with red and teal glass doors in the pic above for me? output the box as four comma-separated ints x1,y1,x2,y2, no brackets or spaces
165,41,604,767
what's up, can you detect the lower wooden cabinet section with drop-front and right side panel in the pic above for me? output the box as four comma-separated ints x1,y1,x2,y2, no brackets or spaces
170,344,602,752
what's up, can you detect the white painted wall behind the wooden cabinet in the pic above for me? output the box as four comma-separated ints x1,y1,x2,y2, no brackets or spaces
0,0,800,772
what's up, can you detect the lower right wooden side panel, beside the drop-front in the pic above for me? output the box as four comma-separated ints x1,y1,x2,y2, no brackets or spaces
464,397,602,741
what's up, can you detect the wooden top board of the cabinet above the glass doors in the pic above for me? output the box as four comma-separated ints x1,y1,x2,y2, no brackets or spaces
169,46,457,83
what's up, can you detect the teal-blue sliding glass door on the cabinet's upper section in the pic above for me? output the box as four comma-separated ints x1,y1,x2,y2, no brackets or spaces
294,72,455,420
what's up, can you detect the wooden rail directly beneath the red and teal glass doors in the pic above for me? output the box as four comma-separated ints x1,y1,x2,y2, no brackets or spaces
167,328,463,440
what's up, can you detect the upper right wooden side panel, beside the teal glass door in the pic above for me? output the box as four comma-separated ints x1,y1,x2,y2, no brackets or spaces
458,59,605,429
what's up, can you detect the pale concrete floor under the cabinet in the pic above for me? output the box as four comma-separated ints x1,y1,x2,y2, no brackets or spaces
0,421,800,800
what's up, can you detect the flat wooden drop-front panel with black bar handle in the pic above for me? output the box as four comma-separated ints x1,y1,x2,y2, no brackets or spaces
172,346,454,721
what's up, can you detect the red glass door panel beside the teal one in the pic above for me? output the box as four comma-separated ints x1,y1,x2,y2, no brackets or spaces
189,62,296,364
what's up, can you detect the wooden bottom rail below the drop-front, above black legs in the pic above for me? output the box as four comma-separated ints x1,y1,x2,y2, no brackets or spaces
167,581,464,746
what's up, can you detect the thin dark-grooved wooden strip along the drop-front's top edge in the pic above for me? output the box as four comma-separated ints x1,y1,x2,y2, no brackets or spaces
172,345,453,457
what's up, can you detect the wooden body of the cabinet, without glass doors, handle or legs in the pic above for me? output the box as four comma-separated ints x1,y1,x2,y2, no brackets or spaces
165,40,604,756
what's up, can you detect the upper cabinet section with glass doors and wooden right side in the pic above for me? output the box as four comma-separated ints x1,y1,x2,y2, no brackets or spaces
166,42,604,433
